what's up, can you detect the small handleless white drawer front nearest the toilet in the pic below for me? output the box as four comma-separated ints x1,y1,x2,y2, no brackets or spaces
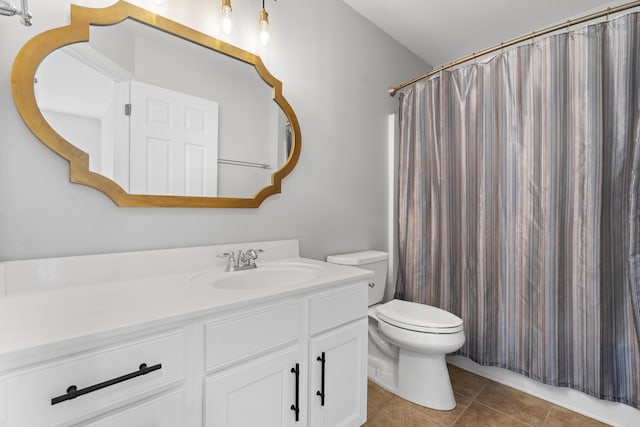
309,282,368,335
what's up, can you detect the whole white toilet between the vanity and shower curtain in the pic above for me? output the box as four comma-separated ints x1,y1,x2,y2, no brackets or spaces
327,250,465,410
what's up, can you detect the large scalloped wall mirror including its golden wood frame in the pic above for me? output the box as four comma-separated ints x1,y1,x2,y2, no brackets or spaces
11,1,301,208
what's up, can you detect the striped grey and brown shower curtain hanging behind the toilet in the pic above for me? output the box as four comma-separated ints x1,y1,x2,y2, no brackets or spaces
396,13,640,408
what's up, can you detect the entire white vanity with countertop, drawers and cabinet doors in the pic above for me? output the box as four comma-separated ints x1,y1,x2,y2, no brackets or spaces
0,242,371,427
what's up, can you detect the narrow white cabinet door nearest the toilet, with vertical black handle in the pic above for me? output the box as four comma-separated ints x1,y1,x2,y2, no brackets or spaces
309,319,368,427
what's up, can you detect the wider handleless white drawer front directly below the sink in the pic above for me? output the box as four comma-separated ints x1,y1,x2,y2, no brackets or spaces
205,302,303,371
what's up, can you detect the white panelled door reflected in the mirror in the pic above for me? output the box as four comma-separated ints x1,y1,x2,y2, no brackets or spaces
130,81,218,197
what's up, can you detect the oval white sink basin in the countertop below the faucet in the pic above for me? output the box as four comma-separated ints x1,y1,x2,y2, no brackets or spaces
192,262,326,289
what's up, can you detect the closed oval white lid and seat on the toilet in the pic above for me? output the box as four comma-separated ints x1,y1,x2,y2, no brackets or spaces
378,299,463,334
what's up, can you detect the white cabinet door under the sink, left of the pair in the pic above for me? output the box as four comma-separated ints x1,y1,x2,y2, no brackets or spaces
205,346,307,427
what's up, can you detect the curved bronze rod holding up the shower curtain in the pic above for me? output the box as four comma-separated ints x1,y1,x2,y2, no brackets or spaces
389,0,640,96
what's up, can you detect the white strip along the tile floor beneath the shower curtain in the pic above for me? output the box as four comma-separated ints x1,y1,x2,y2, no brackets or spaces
447,356,640,427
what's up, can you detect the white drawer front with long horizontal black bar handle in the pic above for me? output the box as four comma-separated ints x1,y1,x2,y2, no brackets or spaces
2,330,185,427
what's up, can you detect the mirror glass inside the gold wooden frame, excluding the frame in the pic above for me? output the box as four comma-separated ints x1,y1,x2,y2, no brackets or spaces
35,19,292,198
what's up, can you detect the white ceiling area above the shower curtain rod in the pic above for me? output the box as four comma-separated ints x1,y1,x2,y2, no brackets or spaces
343,0,629,67
